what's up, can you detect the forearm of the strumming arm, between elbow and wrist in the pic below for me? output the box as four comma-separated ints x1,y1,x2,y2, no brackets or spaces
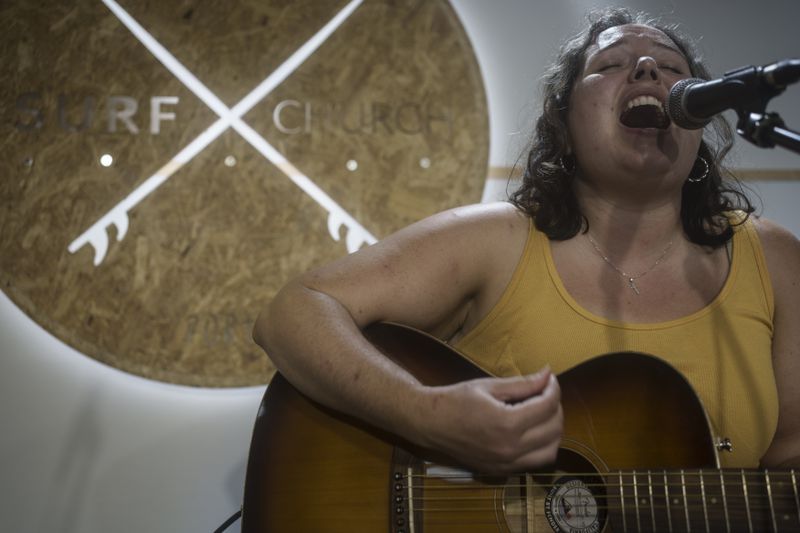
253,282,432,440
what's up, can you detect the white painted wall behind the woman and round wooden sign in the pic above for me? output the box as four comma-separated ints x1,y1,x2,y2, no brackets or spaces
0,0,800,533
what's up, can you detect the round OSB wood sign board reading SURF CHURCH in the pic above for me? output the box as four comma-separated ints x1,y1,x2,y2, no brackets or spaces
0,0,489,387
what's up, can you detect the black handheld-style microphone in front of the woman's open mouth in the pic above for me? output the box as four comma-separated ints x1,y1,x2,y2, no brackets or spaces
667,59,800,130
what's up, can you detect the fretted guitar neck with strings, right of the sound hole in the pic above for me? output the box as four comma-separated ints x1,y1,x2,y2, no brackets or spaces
605,469,800,532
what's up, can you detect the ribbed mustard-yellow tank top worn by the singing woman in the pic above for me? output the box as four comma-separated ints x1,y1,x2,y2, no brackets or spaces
455,216,778,467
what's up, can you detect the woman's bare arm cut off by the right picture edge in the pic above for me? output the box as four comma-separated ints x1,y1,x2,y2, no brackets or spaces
756,219,800,468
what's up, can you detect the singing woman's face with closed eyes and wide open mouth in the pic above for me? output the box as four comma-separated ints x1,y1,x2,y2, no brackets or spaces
567,24,702,195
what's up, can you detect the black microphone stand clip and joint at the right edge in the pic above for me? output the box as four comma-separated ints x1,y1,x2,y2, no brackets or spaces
736,59,800,154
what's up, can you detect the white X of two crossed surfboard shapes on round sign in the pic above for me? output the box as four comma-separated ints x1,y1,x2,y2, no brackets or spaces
68,0,377,266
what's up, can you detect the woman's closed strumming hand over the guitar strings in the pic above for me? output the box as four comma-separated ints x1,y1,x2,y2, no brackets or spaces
412,369,564,474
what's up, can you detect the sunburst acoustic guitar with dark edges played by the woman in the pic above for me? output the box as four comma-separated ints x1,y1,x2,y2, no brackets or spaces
242,324,800,533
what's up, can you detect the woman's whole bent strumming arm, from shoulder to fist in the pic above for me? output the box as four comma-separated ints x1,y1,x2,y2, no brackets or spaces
254,204,562,472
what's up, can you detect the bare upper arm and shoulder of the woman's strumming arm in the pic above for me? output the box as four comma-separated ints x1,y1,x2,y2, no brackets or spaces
299,202,529,332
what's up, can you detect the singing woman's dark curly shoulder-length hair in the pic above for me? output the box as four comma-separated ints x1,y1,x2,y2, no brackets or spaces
510,8,754,247
